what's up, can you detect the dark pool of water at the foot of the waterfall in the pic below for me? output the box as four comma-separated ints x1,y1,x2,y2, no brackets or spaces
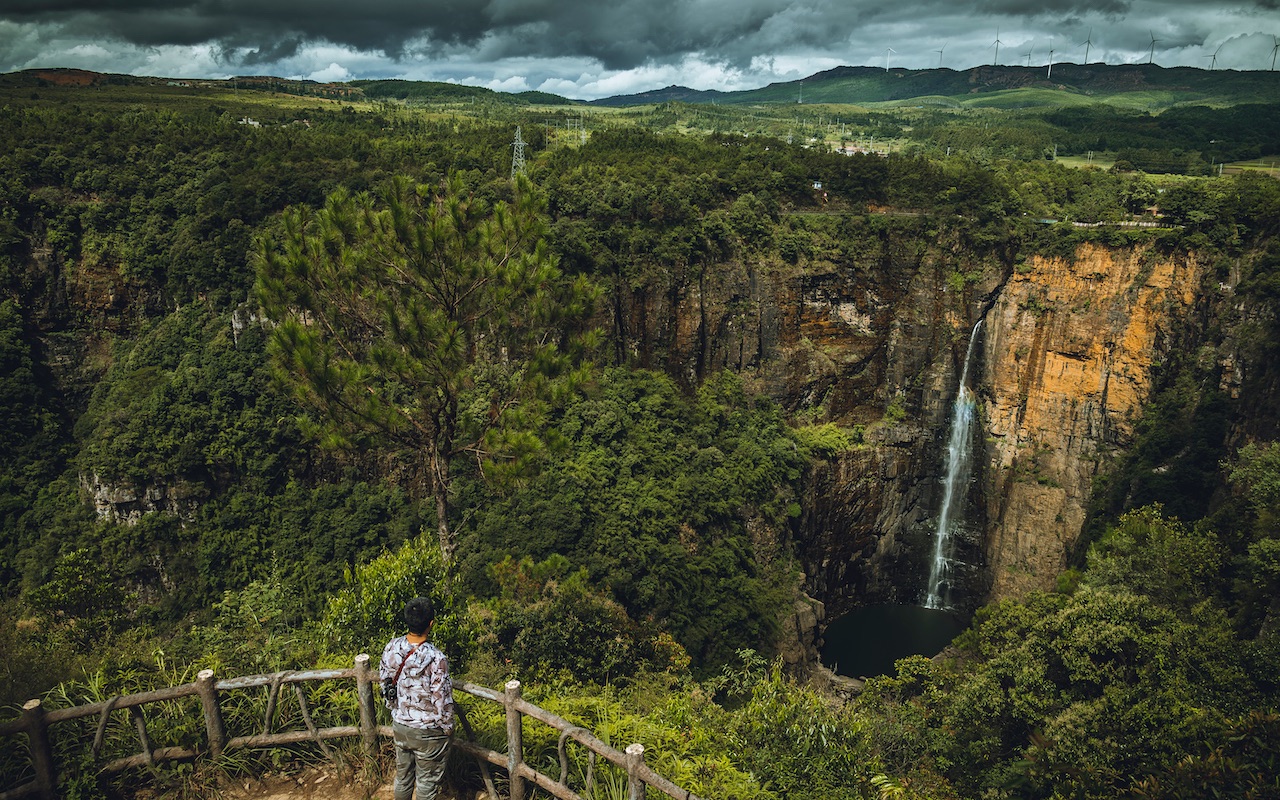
822,605,969,677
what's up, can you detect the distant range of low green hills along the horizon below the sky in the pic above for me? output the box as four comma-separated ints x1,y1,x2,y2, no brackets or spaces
0,63,1280,110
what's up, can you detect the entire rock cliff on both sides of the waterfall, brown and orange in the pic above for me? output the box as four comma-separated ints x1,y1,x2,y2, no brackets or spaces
614,223,1201,616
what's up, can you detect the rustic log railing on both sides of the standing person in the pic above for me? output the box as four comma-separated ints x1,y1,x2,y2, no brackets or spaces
0,653,700,800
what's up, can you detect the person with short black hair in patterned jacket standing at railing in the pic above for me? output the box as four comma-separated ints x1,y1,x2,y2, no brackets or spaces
379,598,453,800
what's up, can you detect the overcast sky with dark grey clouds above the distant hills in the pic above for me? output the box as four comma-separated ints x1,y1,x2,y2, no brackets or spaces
0,0,1280,100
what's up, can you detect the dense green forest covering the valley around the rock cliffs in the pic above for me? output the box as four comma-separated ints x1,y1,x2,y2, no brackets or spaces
0,73,1280,799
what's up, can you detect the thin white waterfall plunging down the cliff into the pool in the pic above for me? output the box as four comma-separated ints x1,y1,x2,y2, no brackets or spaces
924,320,982,608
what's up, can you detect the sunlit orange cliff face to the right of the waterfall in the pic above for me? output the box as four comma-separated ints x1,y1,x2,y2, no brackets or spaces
983,246,1201,596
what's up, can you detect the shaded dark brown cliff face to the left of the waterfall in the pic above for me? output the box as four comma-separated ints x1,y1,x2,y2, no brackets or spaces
611,216,1007,617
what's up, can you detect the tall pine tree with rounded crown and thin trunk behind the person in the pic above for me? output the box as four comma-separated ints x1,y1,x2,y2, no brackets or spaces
255,175,595,563
